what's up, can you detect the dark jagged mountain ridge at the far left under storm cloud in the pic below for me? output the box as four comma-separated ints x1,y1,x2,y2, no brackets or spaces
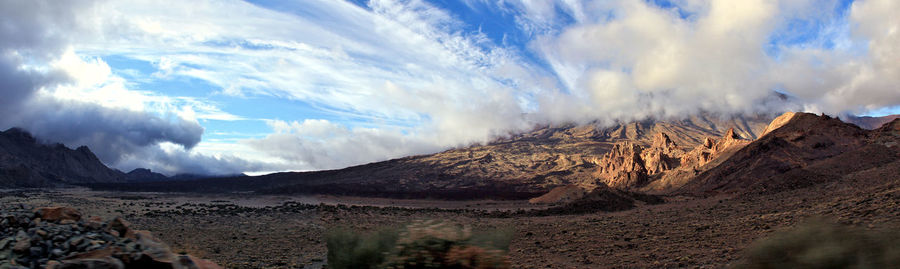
0,128,124,187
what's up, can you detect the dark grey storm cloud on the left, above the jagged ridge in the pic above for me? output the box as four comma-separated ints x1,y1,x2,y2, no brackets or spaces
0,1,203,172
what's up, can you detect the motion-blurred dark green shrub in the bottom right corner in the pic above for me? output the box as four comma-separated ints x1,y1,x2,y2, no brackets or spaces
735,220,900,269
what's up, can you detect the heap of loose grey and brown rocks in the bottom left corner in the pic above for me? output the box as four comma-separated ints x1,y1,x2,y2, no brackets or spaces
0,206,221,269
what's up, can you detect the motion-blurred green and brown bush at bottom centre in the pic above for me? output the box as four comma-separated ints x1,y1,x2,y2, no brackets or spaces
326,221,512,269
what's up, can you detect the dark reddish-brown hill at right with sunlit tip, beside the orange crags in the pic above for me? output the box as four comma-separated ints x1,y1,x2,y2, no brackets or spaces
677,113,900,195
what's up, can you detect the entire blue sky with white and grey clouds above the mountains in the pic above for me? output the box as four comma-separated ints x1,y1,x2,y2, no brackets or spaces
0,0,900,175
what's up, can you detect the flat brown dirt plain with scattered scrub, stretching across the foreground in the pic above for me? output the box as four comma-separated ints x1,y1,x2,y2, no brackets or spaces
0,162,900,268
